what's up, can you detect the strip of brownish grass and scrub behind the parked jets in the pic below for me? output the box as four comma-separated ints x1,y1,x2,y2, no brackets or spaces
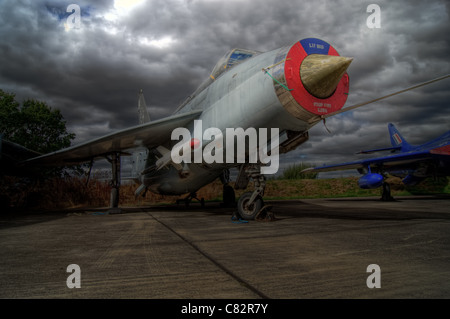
0,177,450,210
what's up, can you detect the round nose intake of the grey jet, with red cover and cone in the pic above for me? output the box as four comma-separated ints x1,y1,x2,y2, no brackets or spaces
272,38,353,123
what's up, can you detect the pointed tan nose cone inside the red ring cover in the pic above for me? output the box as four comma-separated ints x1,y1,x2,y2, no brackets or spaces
300,54,353,99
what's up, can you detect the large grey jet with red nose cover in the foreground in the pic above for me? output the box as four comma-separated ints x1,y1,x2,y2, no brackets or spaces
15,38,449,219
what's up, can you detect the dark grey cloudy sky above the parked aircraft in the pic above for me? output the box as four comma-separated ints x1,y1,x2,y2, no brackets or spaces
0,0,450,178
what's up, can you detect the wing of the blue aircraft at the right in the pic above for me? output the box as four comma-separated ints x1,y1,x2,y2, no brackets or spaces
302,150,436,173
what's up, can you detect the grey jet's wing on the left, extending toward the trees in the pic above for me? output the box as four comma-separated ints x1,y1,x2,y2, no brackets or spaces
22,110,202,166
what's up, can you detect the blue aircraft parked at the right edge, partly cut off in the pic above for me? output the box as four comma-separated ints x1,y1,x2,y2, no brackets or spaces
303,123,450,200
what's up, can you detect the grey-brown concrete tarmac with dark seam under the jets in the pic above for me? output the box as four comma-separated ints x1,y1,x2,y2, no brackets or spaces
0,197,450,299
